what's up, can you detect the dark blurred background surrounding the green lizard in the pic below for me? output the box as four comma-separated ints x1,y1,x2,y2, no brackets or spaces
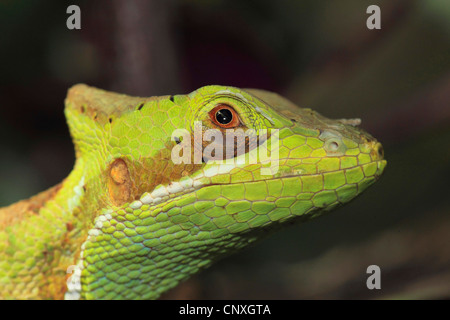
0,0,450,299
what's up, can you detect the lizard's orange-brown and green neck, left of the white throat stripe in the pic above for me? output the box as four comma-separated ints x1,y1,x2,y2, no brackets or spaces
0,159,106,299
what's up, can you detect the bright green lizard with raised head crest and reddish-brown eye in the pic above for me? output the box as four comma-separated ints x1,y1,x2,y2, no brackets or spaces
0,85,386,299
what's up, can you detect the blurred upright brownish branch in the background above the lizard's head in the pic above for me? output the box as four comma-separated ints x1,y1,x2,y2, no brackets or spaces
113,0,178,96
